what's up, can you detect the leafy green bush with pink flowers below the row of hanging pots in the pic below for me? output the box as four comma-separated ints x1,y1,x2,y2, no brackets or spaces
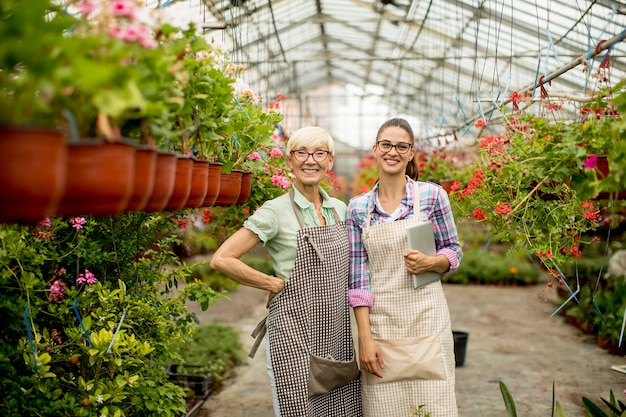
0,213,222,416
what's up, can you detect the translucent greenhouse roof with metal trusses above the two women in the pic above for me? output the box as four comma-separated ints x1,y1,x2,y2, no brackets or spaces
161,0,626,141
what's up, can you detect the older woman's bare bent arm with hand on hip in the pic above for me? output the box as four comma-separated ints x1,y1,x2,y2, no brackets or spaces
211,227,285,294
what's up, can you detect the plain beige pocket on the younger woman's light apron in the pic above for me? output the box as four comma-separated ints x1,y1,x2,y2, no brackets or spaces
363,334,446,385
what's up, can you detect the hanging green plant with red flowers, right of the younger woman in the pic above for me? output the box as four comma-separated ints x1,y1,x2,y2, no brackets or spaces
452,83,623,268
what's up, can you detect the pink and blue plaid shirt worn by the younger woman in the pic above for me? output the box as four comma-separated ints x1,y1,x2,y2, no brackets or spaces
346,177,463,307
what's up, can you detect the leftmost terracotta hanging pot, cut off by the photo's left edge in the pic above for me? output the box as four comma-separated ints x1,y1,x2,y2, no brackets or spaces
0,126,67,223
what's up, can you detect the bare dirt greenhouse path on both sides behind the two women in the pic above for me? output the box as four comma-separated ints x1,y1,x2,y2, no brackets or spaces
189,285,626,417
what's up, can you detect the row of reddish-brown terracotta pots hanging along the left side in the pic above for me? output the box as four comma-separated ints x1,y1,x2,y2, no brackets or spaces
0,127,252,223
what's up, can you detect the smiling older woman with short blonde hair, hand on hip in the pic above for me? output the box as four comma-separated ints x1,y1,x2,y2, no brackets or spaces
211,126,361,417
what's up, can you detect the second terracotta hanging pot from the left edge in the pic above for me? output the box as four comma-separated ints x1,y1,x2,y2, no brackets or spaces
57,140,136,216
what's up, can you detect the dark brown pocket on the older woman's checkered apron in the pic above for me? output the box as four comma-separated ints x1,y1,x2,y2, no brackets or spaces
309,354,361,398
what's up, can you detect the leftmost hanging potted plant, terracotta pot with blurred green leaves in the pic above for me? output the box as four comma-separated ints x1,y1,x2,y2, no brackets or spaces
0,0,75,223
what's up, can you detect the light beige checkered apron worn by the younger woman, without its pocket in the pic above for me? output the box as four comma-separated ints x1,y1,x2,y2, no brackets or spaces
363,183,458,417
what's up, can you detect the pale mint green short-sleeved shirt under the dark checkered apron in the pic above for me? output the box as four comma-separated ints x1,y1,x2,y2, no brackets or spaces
243,187,347,280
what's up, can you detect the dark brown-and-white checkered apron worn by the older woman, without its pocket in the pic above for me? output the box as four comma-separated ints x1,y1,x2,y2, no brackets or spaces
267,190,363,417
